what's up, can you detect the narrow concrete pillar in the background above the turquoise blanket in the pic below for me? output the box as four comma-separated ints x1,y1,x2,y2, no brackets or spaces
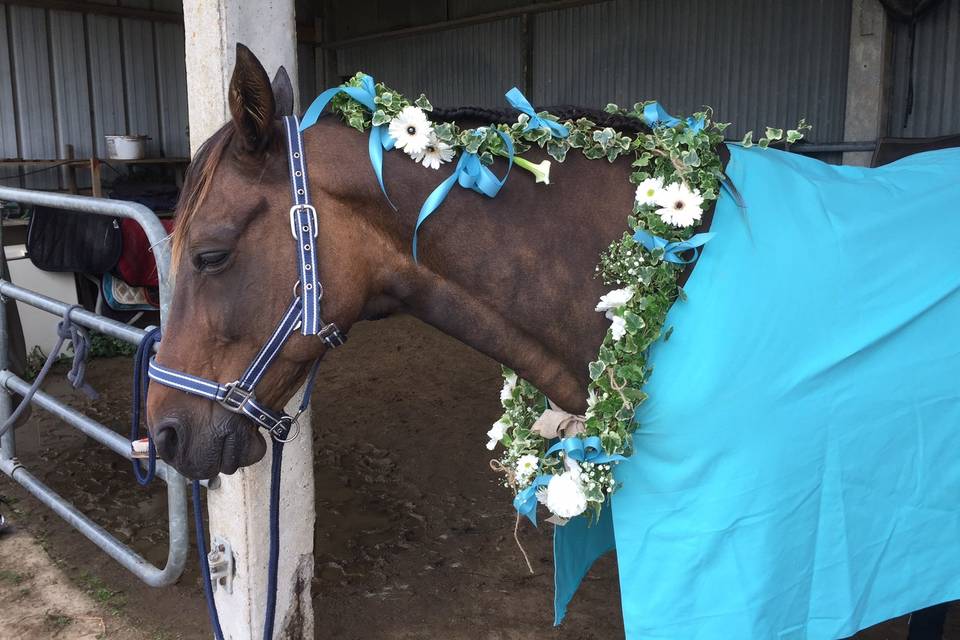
844,0,891,167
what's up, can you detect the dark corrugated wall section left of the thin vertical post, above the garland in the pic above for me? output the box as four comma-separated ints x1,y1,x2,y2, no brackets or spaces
337,18,523,106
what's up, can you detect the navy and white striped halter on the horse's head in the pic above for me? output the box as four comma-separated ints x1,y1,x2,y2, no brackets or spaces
149,116,346,442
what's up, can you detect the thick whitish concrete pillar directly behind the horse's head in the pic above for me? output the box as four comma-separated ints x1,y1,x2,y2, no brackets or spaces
183,0,315,640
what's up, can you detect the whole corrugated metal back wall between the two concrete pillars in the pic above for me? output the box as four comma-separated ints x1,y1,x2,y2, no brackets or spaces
326,0,851,142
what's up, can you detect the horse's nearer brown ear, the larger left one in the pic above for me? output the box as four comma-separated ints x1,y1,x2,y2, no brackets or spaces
230,42,276,151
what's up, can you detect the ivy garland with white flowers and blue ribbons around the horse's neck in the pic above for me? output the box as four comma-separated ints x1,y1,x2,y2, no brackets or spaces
322,74,810,525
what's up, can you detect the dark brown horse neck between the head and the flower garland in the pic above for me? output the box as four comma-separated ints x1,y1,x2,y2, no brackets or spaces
312,119,633,412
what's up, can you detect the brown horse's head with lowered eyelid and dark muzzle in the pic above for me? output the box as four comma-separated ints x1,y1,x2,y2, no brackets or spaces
148,45,394,478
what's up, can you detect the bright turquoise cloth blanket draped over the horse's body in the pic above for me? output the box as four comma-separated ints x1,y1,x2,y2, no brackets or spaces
554,147,960,640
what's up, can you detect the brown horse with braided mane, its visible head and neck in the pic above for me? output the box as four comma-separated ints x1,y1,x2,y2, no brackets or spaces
148,46,708,478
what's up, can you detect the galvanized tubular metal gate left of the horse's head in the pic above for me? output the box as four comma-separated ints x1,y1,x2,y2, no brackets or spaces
0,187,189,587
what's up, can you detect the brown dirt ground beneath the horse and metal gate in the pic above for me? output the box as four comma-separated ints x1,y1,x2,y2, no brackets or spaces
0,318,960,640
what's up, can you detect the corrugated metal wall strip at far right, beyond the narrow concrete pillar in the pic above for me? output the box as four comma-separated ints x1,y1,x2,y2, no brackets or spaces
887,0,960,137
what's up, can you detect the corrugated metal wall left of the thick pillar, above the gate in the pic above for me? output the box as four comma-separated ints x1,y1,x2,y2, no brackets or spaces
0,0,190,188
